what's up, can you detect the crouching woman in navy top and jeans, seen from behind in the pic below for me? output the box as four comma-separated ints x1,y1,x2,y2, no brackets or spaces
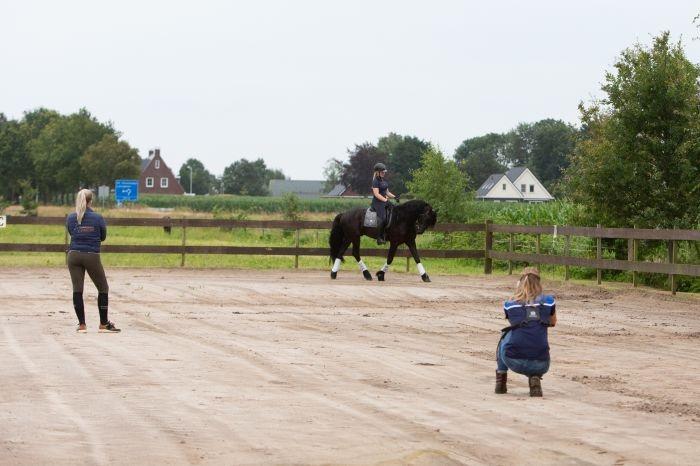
496,267,557,396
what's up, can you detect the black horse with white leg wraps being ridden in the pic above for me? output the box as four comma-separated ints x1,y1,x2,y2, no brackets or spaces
328,200,437,282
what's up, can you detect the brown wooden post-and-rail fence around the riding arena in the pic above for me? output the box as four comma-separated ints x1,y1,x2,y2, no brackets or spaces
0,216,700,294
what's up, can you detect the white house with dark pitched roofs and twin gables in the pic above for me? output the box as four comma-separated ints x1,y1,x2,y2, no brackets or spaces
476,167,554,202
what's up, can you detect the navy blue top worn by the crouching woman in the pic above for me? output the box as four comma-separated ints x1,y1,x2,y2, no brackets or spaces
503,295,556,360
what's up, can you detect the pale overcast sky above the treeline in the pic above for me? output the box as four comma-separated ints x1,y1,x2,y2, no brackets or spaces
0,0,700,179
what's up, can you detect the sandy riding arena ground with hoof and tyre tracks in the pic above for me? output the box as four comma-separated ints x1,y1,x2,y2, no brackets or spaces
0,264,700,465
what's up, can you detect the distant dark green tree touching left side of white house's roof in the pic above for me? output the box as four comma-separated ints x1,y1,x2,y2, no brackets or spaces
454,133,507,190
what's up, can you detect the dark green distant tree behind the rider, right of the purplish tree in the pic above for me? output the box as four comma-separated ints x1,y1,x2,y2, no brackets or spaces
377,133,430,194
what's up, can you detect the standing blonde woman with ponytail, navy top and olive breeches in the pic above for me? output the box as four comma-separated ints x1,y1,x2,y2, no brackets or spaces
66,189,121,333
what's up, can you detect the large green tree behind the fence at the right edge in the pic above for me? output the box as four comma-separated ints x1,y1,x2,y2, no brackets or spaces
566,32,700,227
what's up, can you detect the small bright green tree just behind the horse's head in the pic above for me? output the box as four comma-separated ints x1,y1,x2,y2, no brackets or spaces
408,148,469,221
